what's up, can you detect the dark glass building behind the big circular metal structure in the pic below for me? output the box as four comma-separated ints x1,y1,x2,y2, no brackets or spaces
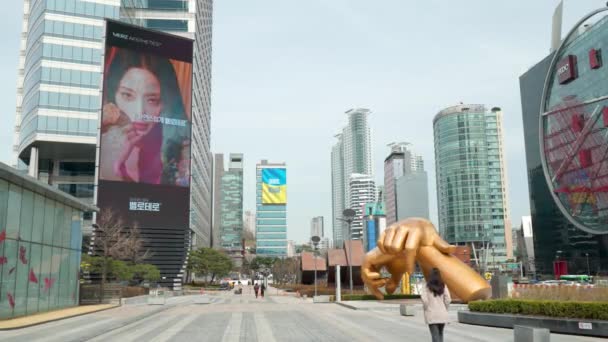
519,55,608,274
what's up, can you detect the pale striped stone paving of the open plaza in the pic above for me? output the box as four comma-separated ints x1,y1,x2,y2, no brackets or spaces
0,288,600,342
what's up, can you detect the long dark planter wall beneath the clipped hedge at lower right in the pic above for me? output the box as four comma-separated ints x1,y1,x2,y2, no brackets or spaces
458,311,608,337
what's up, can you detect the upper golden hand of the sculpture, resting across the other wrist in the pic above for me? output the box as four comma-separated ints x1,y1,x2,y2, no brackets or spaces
378,218,456,274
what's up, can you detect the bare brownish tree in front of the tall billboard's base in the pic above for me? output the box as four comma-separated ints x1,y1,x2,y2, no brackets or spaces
92,209,149,302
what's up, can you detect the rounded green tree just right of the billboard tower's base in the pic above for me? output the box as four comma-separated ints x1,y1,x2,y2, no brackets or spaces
187,247,233,283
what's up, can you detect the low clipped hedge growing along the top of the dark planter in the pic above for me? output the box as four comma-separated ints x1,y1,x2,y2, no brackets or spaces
469,299,608,320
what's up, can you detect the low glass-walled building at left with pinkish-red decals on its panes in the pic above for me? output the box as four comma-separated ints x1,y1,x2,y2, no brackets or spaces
0,163,94,319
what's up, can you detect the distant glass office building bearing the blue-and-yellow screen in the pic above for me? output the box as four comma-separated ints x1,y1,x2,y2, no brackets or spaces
255,160,287,257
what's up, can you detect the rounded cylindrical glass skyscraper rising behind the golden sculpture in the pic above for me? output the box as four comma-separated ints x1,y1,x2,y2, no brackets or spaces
433,104,512,262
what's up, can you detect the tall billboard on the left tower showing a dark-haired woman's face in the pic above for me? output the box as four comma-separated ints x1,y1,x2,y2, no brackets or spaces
97,20,192,228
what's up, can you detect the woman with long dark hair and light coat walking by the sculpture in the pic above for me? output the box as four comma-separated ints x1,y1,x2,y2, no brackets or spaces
420,268,452,342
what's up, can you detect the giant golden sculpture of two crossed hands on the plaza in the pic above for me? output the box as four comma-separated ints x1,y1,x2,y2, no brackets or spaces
361,218,492,302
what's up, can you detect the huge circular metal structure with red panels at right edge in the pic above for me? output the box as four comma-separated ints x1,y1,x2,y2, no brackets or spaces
539,8,608,234
